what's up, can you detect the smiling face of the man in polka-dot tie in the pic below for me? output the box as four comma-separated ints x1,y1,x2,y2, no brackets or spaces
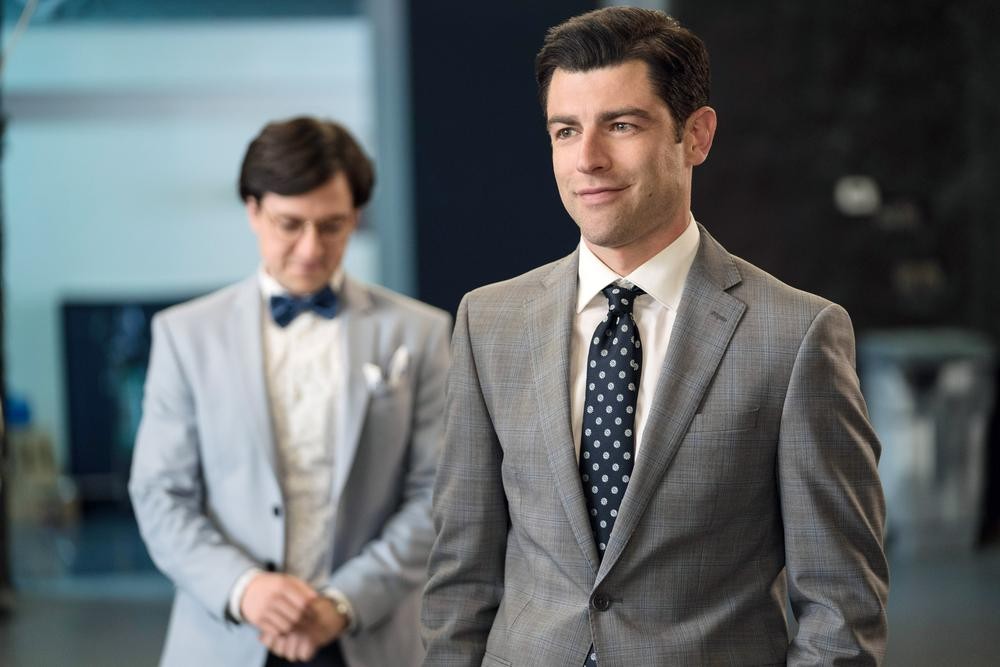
546,60,714,259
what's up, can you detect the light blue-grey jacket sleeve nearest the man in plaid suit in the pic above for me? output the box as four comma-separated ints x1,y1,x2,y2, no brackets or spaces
327,316,451,632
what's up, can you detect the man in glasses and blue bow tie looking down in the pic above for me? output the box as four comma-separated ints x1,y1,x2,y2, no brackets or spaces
129,118,451,667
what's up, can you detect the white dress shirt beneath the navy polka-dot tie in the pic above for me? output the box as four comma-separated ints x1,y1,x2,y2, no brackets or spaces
570,216,701,460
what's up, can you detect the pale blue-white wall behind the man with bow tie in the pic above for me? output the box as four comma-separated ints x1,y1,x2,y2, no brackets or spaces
3,18,379,470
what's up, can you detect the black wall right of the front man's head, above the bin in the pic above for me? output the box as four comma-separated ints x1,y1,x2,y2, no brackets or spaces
673,0,1000,335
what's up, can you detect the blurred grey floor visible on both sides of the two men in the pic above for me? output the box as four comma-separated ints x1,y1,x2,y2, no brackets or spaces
0,516,1000,667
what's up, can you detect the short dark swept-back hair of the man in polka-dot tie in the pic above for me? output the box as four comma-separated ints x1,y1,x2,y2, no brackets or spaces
535,7,711,141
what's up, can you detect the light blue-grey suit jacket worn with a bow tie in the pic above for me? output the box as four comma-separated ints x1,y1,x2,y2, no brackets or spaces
129,276,451,667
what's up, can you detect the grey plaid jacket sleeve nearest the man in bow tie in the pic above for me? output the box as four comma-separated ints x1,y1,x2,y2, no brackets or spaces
421,297,510,666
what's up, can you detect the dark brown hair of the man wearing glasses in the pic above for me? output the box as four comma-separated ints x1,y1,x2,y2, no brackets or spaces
239,116,375,208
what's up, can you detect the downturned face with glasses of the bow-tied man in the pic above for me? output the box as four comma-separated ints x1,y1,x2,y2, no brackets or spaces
246,172,358,296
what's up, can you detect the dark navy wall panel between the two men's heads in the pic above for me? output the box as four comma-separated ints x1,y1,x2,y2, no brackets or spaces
410,0,594,311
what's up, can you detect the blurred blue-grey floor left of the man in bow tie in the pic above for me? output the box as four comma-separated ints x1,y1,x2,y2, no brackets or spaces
0,505,173,667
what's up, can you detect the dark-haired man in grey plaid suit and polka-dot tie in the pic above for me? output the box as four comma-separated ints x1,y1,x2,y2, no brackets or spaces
422,7,888,667
